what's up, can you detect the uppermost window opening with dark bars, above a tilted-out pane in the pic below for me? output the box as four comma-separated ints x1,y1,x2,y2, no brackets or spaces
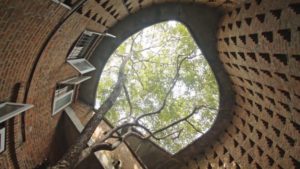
68,30,101,59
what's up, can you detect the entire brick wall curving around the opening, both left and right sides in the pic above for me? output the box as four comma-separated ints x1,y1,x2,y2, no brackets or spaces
0,0,300,169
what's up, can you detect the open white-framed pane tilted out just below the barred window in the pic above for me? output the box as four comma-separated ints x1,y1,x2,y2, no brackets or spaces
67,59,96,74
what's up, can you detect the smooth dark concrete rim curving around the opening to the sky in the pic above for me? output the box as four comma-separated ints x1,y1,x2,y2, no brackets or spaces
79,3,235,166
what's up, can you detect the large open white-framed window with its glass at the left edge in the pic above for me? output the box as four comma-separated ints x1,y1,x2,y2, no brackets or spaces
0,102,33,123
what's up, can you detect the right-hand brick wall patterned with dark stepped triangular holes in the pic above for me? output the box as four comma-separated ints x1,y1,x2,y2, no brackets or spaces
182,0,300,169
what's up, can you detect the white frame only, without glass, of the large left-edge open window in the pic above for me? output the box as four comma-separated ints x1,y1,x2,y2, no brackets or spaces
0,102,33,123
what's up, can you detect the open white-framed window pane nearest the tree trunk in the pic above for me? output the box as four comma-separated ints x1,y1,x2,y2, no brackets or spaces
52,87,74,115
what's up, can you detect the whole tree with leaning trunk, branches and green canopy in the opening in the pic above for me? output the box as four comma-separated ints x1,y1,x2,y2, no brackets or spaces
50,21,218,167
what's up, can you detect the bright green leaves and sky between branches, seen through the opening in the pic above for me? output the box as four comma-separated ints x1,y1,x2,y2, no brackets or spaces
97,21,219,153
